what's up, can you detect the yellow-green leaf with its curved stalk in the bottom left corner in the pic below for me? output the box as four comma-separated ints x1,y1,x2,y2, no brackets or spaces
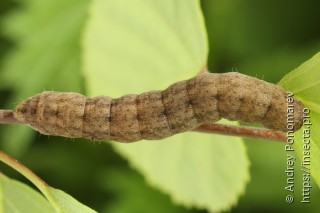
0,151,95,213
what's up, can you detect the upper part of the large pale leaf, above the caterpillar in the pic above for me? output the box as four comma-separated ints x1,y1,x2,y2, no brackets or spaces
83,0,208,96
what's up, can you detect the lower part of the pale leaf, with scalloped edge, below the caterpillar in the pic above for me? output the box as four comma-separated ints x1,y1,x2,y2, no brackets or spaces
115,130,248,212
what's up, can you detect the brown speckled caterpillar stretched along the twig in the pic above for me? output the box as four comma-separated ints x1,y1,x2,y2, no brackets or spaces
14,72,304,142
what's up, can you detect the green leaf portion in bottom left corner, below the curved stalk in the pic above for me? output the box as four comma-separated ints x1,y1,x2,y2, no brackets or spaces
0,174,55,213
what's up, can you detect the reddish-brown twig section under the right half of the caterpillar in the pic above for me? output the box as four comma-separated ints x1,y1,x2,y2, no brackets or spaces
193,124,287,142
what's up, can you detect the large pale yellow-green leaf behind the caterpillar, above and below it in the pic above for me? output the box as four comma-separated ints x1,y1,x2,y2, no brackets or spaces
83,0,249,211
